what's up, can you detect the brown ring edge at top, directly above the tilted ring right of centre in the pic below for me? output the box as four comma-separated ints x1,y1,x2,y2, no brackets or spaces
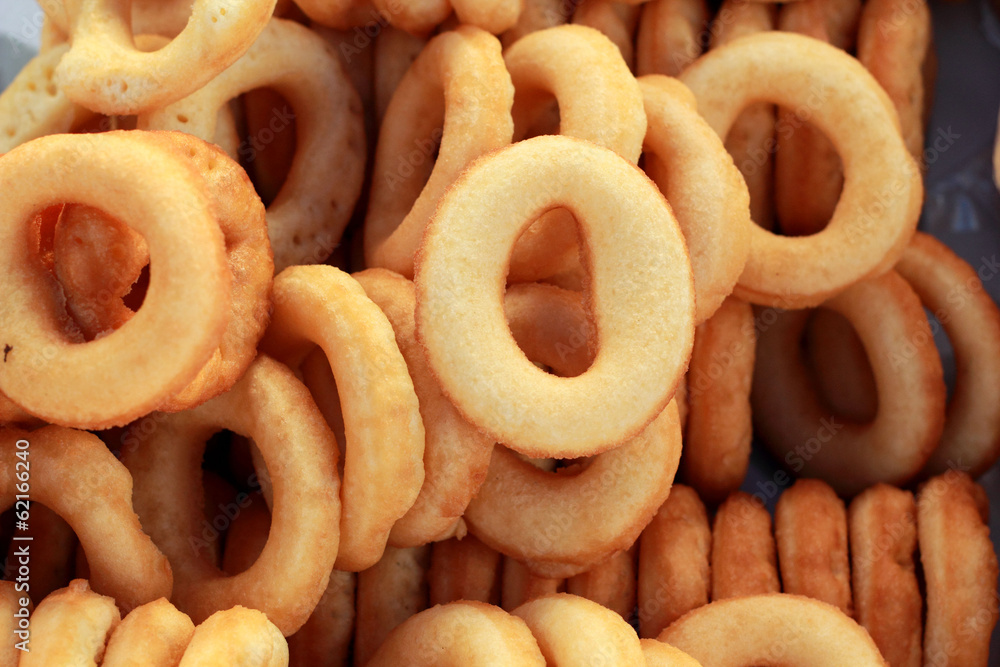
635,0,709,76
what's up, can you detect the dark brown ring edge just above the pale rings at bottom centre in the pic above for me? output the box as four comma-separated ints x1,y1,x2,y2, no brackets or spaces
427,535,501,607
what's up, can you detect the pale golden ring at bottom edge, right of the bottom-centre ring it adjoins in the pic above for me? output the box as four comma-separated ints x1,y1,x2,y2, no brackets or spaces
511,593,645,665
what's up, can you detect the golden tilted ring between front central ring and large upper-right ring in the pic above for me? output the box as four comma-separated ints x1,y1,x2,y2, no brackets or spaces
639,76,752,324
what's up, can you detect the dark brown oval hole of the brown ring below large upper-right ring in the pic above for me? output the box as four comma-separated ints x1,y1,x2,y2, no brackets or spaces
801,308,879,424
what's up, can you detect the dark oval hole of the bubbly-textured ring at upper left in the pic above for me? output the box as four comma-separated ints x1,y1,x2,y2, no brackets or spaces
235,88,298,206
